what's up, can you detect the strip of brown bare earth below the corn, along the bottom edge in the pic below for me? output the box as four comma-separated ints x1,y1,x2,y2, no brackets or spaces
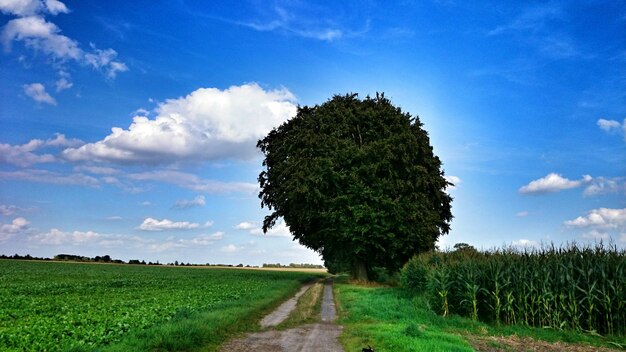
468,335,615,352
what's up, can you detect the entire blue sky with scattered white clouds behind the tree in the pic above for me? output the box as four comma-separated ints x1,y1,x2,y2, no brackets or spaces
0,0,626,265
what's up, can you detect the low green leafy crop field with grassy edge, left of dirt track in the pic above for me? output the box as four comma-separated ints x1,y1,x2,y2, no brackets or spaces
0,260,319,351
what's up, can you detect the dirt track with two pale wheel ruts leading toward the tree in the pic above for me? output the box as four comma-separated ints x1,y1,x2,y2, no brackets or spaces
221,281,343,352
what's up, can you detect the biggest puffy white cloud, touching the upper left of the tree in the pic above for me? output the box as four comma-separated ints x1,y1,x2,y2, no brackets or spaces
63,83,296,164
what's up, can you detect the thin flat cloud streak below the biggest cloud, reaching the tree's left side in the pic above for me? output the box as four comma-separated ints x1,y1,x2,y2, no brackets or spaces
127,170,259,193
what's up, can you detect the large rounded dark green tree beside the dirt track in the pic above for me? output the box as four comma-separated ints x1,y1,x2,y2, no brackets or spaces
257,94,452,279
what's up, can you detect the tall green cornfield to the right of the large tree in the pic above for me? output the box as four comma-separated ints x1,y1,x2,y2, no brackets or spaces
401,245,626,336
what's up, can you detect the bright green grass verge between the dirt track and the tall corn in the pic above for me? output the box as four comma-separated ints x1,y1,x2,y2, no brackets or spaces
335,281,626,352
